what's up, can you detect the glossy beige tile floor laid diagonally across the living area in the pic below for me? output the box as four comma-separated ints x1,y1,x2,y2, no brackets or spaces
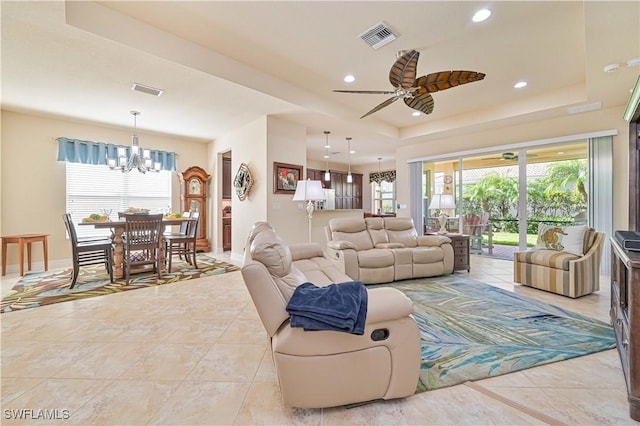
0,256,638,425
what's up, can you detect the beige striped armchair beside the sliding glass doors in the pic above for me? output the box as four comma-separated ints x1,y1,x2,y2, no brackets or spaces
513,228,605,298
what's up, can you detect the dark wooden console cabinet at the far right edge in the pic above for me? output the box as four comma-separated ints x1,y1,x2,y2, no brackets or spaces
610,238,640,421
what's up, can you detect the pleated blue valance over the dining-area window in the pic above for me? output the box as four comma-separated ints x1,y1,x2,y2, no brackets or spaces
56,137,176,171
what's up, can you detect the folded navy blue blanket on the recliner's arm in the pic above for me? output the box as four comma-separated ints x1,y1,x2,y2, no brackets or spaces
287,281,367,335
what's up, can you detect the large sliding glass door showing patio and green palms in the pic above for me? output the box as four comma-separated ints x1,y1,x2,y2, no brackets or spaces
422,140,589,259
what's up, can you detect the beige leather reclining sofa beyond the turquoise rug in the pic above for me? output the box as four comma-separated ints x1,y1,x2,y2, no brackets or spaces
327,217,453,284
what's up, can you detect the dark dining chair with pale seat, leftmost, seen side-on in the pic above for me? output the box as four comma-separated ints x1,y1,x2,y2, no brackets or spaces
62,213,113,289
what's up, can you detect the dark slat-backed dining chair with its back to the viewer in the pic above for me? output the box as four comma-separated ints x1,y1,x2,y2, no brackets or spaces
122,214,163,285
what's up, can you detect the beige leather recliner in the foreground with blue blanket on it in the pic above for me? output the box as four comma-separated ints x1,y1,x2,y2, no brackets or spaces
242,222,421,408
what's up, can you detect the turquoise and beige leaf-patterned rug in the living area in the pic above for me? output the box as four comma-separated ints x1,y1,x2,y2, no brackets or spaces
376,275,615,392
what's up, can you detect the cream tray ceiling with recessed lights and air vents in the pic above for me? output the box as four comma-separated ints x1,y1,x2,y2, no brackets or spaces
0,1,640,165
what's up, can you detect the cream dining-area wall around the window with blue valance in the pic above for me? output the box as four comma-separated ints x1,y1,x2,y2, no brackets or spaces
0,110,207,269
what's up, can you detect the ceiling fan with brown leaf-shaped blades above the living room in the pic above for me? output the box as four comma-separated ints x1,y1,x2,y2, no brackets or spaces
334,50,485,118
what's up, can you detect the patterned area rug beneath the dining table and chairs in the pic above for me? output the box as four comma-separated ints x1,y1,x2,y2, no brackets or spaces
0,254,240,313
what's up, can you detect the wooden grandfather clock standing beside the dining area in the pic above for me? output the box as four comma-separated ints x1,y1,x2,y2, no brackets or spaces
178,166,211,252
